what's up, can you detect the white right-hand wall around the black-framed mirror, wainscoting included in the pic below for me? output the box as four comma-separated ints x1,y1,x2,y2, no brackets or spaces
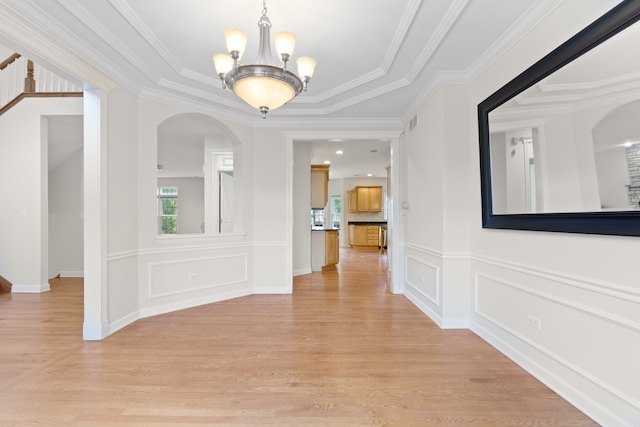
464,0,640,426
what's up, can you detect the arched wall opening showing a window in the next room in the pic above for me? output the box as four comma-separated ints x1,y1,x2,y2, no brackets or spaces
157,114,234,235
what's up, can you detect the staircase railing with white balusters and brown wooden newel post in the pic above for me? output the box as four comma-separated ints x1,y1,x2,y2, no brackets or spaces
0,53,82,115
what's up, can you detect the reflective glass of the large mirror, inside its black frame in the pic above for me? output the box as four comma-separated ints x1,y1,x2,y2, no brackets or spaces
489,15,640,214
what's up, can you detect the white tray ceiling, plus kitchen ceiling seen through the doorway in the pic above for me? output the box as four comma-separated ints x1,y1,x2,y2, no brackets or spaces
0,0,577,176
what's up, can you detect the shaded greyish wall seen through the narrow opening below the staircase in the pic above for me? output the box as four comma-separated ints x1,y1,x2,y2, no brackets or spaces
48,148,84,278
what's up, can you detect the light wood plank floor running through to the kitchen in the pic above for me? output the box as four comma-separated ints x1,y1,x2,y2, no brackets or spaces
0,250,596,427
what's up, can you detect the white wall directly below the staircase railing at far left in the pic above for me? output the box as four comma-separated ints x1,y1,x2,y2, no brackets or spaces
0,98,82,292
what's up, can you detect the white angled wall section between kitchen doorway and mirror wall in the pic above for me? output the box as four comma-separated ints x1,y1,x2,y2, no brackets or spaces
404,87,470,328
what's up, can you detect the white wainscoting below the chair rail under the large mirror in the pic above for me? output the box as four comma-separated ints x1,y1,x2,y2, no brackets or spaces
471,260,640,426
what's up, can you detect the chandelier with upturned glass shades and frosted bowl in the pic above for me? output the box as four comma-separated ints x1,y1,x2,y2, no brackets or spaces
213,0,316,119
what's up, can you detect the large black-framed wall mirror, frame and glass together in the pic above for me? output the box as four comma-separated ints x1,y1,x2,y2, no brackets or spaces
478,0,640,236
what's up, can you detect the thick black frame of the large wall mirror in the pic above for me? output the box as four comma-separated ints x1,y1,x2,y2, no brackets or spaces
478,0,640,236
